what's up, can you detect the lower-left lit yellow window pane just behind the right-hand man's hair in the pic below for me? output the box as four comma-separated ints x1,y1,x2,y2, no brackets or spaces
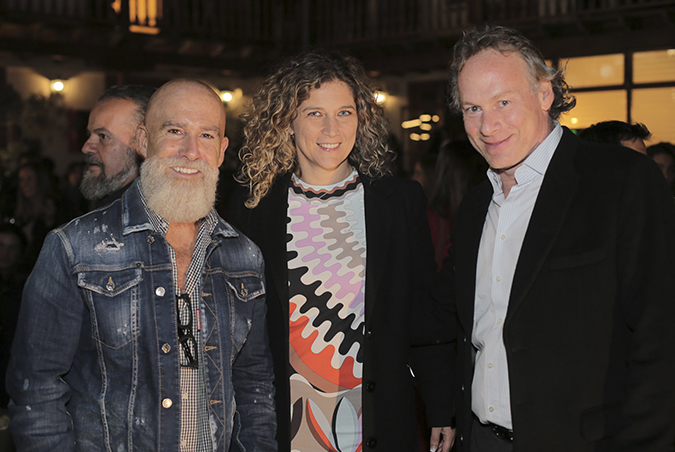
560,90,628,129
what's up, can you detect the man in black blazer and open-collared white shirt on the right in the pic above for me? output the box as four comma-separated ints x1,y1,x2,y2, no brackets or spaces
441,26,675,452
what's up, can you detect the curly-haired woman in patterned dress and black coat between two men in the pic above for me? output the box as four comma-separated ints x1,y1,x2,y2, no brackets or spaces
229,51,454,452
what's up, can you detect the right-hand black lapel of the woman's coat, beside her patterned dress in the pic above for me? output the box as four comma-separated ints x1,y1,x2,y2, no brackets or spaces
359,174,396,320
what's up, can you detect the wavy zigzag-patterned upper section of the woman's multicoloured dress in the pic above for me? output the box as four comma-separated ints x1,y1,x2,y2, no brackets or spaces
287,172,366,392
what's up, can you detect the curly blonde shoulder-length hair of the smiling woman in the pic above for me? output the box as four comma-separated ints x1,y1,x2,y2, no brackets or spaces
236,50,395,209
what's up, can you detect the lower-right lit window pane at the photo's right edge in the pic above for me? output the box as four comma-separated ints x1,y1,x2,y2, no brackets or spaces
631,87,675,144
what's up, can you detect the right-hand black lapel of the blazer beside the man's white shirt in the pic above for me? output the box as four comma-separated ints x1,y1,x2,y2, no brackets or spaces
507,129,579,321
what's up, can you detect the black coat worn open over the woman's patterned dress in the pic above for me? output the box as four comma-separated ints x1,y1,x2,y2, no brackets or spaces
228,175,451,452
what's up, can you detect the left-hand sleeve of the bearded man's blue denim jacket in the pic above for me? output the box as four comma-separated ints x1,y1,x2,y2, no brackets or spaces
7,232,86,452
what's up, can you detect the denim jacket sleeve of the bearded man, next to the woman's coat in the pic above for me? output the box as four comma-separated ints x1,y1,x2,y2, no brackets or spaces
232,264,277,452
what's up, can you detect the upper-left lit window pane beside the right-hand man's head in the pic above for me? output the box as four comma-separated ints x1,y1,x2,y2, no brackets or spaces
565,53,624,88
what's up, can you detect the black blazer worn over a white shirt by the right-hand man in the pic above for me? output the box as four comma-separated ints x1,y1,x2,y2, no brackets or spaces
443,129,675,452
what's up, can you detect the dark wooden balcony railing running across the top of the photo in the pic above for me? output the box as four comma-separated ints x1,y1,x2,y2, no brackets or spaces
0,0,675,46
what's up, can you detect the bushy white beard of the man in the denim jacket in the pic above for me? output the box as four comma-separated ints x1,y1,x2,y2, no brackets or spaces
140,156,218,223
